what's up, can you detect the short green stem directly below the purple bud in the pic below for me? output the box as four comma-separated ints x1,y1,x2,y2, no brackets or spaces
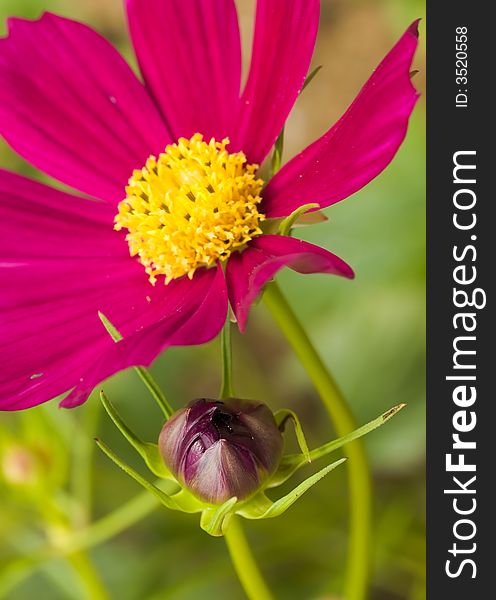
224,516,273,600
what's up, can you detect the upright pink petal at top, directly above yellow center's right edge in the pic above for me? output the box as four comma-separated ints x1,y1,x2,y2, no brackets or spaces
233,0,320,164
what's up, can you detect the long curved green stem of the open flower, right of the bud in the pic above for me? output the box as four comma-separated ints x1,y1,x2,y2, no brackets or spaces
264,282,372,600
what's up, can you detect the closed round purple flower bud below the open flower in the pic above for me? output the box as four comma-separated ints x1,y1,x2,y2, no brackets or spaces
159,398,283,504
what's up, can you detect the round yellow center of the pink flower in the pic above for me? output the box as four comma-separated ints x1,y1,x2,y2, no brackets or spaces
115,133,264,284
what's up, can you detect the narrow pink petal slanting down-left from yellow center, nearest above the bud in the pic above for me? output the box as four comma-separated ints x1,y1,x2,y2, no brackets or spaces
60,265,227,408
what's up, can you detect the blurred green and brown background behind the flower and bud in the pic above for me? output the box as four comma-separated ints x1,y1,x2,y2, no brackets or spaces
0,0,425,600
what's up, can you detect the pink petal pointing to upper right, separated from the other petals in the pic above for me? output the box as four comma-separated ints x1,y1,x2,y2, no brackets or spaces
264,21,418,217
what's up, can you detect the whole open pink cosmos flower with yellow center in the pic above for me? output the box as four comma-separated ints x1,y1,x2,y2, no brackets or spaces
0,0,418,410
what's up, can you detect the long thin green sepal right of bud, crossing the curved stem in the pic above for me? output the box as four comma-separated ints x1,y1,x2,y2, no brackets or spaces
267,404,406,488
